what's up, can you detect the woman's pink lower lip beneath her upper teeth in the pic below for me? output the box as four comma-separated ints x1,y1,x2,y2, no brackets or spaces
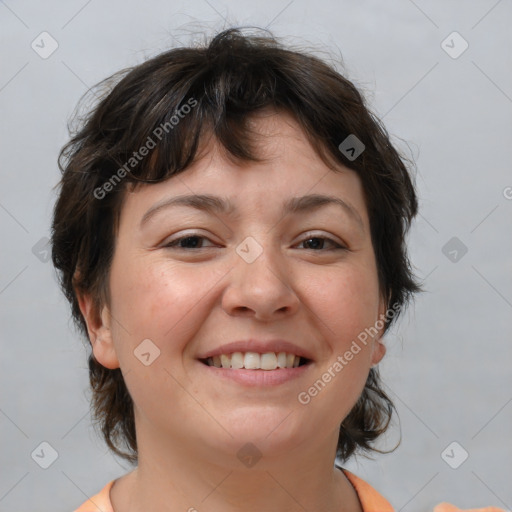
198,361,311,386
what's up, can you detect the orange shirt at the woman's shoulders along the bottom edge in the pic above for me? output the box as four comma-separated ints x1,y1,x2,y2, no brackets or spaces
74,469,506,512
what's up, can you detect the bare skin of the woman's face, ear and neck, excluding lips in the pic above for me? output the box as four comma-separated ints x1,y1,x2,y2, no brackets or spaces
80,113,385,512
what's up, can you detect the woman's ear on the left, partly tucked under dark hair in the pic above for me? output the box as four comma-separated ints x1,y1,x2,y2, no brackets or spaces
77,293,120,370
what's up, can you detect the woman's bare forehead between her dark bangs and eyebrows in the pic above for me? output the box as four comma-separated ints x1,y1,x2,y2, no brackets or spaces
123,109,367,230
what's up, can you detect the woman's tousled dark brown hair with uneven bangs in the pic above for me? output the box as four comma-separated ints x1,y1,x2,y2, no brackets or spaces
52,28,421,463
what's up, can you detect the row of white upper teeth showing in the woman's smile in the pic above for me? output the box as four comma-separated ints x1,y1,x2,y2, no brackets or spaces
207,352,300,370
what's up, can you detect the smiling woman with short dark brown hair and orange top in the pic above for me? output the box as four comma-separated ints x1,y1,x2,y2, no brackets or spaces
52,29,504,512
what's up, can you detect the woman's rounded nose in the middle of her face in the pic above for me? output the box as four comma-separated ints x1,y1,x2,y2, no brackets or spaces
222,240,300,321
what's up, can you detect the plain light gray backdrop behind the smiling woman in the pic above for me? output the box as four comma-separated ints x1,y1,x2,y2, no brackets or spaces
0,0,512,512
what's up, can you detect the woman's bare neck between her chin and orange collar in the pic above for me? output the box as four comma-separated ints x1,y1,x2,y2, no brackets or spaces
111,422,362,512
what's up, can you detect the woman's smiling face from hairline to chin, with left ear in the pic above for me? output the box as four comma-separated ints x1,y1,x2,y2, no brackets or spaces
80,114,384,468
